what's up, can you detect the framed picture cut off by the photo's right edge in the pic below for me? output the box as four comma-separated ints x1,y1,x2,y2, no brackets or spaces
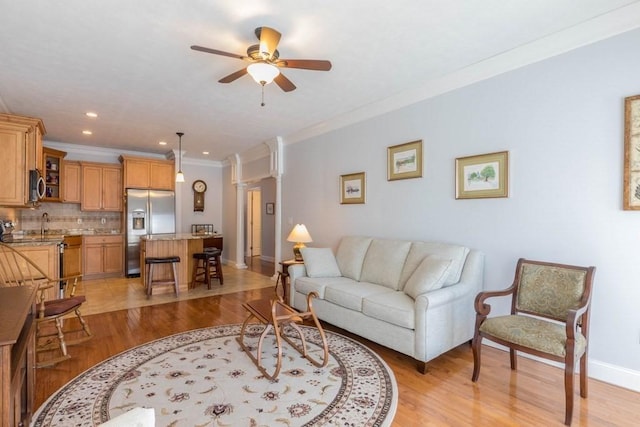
623,95,640,211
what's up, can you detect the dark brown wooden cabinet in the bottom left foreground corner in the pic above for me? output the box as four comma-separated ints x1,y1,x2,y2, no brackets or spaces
0,285,37,427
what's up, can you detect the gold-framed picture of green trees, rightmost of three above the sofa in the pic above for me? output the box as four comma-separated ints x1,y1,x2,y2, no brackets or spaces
456,151,509,199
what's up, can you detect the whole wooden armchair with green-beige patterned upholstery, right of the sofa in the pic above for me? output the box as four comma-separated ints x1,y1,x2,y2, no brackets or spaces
471,258,595,425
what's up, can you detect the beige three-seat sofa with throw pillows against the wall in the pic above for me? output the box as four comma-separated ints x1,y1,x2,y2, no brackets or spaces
288,236,484,373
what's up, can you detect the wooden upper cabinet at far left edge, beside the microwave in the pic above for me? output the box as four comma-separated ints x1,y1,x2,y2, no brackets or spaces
0,114,45,206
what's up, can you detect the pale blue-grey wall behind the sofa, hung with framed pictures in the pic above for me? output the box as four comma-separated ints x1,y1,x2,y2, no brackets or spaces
281,30,640,390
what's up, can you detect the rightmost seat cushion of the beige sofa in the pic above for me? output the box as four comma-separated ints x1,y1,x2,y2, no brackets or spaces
362,291,415,329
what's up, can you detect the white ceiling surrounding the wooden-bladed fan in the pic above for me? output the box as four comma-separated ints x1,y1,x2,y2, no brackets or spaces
0,0,640,161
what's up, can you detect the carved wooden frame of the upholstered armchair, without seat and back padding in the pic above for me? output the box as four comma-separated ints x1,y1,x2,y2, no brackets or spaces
471,258,595,425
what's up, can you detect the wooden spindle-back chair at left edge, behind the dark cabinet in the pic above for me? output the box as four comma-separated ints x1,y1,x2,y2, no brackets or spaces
0,243,92,367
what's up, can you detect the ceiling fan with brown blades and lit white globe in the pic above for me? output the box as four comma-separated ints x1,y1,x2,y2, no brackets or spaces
191,27,331,95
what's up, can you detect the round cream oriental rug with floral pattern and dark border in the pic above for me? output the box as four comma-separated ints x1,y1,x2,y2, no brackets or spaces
32,325,398,427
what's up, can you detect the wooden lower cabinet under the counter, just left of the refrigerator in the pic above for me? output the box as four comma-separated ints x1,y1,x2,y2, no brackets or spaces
82,235,124,279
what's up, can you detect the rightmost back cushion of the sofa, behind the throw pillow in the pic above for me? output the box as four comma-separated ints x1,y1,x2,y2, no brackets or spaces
399,242,469,289
